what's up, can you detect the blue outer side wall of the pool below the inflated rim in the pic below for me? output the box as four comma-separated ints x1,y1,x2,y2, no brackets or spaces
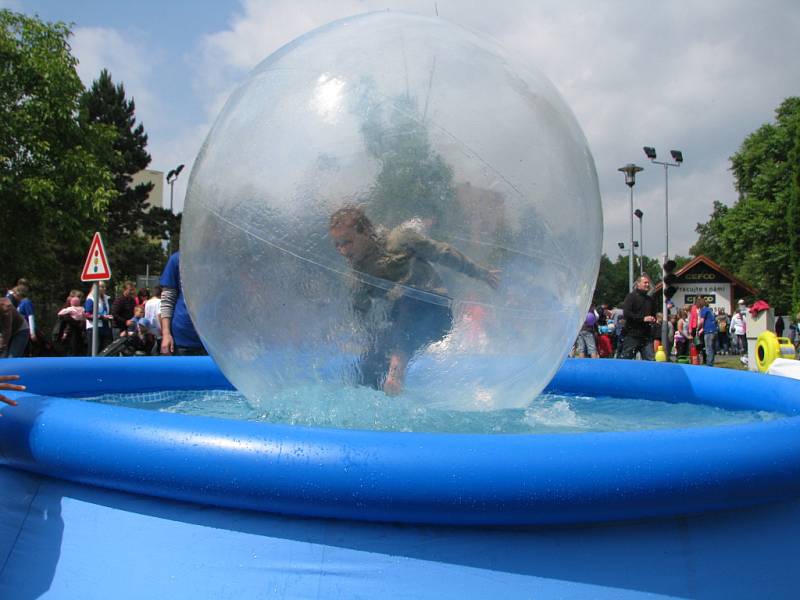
0,467,800,600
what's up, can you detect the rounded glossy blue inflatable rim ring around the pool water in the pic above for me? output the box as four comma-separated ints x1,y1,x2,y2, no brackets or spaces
0,358,800,525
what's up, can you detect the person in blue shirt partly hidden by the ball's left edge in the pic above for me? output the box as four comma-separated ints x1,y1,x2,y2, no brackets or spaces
160,252,206,356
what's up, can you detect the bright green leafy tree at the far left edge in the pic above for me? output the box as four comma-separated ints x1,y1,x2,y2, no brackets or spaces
0,10,114,314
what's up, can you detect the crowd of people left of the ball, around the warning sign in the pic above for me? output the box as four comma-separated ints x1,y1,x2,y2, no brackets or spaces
0,252,205,358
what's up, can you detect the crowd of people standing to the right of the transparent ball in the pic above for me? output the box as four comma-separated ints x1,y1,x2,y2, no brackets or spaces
572,275,800,366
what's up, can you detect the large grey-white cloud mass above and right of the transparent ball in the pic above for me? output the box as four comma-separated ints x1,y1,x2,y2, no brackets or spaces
181,0,800,256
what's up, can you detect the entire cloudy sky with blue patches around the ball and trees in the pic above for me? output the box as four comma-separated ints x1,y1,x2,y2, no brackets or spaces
6,0,800,257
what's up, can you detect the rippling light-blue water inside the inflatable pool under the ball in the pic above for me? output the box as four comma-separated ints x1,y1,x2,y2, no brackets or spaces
84,390,784,434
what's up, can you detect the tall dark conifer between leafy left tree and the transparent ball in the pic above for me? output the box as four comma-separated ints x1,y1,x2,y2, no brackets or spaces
81,69,172,281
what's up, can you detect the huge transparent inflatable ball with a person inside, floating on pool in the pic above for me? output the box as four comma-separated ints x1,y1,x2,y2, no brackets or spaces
181,12,603,410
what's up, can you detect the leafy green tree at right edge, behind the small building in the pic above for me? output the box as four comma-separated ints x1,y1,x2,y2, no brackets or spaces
691,97,800,314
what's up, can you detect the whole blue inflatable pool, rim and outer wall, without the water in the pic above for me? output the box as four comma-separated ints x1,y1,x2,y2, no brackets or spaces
0,359,800,600
